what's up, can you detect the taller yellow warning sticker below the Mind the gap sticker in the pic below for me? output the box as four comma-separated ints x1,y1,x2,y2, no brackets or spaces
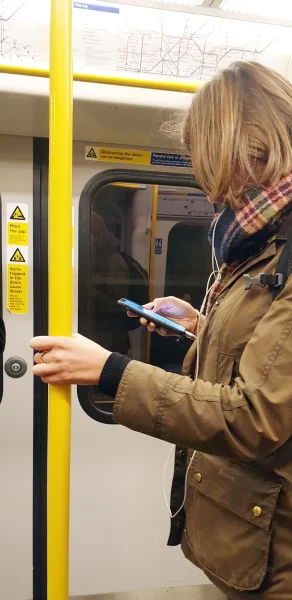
7,246,28,315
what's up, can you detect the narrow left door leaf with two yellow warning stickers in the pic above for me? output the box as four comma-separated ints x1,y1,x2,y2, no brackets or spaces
0,136,35,600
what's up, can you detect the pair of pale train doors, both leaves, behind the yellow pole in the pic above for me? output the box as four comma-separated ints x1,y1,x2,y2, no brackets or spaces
0,136,218,600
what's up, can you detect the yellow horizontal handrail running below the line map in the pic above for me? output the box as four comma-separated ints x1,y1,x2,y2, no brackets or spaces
0,64,204,94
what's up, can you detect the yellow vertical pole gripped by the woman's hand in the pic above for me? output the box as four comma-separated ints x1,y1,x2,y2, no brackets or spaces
47,0,73,600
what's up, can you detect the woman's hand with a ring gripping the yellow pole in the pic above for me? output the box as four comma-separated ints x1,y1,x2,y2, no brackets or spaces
30,334,111,385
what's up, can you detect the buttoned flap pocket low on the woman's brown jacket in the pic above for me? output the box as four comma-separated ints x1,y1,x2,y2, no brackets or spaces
185,453,282,591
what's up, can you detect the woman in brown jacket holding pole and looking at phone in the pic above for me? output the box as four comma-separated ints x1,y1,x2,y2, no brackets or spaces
31,63,292,600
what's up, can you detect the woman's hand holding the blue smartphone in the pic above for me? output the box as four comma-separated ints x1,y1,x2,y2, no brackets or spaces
128,296,205,336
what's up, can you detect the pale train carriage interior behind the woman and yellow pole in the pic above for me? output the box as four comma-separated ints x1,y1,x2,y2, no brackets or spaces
0,0,292,600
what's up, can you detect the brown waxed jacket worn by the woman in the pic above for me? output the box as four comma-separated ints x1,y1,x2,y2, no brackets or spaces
114,219,292,600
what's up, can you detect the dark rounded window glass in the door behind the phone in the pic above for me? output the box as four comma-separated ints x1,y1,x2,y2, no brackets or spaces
83,183,214,420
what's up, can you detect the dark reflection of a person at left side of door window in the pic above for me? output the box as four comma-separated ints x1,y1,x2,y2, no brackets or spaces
91,213,130,354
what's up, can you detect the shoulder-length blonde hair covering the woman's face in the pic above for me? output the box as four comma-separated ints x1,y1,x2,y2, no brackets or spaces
183,62,292,208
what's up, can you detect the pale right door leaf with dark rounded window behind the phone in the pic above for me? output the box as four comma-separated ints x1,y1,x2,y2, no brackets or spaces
71,143,213,598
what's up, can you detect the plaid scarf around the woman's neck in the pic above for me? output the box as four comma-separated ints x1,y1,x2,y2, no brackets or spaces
205,173,292,315
